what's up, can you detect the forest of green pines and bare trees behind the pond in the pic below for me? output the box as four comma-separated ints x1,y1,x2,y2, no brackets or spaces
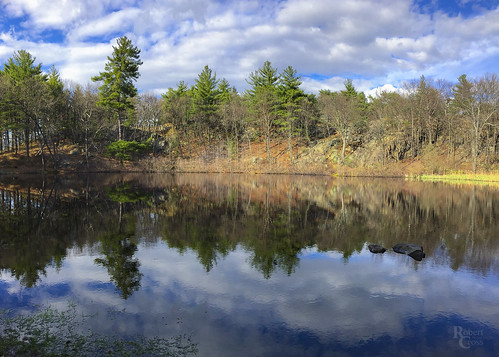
0,37,499,173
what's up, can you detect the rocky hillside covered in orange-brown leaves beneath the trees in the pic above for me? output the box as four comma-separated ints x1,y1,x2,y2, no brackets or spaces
0,136,499,176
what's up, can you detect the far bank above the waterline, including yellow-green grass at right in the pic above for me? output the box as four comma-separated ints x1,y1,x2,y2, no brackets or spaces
0,138,499,186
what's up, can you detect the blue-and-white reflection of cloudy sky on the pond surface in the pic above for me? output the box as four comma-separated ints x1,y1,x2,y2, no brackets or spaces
1,242,499,356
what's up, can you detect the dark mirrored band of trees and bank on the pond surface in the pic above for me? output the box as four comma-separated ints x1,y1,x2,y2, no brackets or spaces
0,175,499,290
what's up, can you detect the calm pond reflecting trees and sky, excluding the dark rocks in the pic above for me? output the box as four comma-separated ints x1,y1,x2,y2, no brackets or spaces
0,174,499,356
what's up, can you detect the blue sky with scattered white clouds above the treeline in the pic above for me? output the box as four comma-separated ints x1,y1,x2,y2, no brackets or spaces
0,0,499,94
